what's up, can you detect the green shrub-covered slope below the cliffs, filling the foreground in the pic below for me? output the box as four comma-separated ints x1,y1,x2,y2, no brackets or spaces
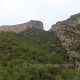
0,29,77,80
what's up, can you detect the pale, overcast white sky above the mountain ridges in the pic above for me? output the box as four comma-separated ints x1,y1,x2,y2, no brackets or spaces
0,0,80,30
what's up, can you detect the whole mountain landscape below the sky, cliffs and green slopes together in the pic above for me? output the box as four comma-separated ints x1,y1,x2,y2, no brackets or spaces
0,14,80,80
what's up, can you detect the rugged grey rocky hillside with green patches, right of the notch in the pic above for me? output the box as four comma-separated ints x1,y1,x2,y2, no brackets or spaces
50,13,80,61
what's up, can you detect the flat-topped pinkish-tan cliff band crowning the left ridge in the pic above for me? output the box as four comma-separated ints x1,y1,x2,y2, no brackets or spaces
0,20,43,33
